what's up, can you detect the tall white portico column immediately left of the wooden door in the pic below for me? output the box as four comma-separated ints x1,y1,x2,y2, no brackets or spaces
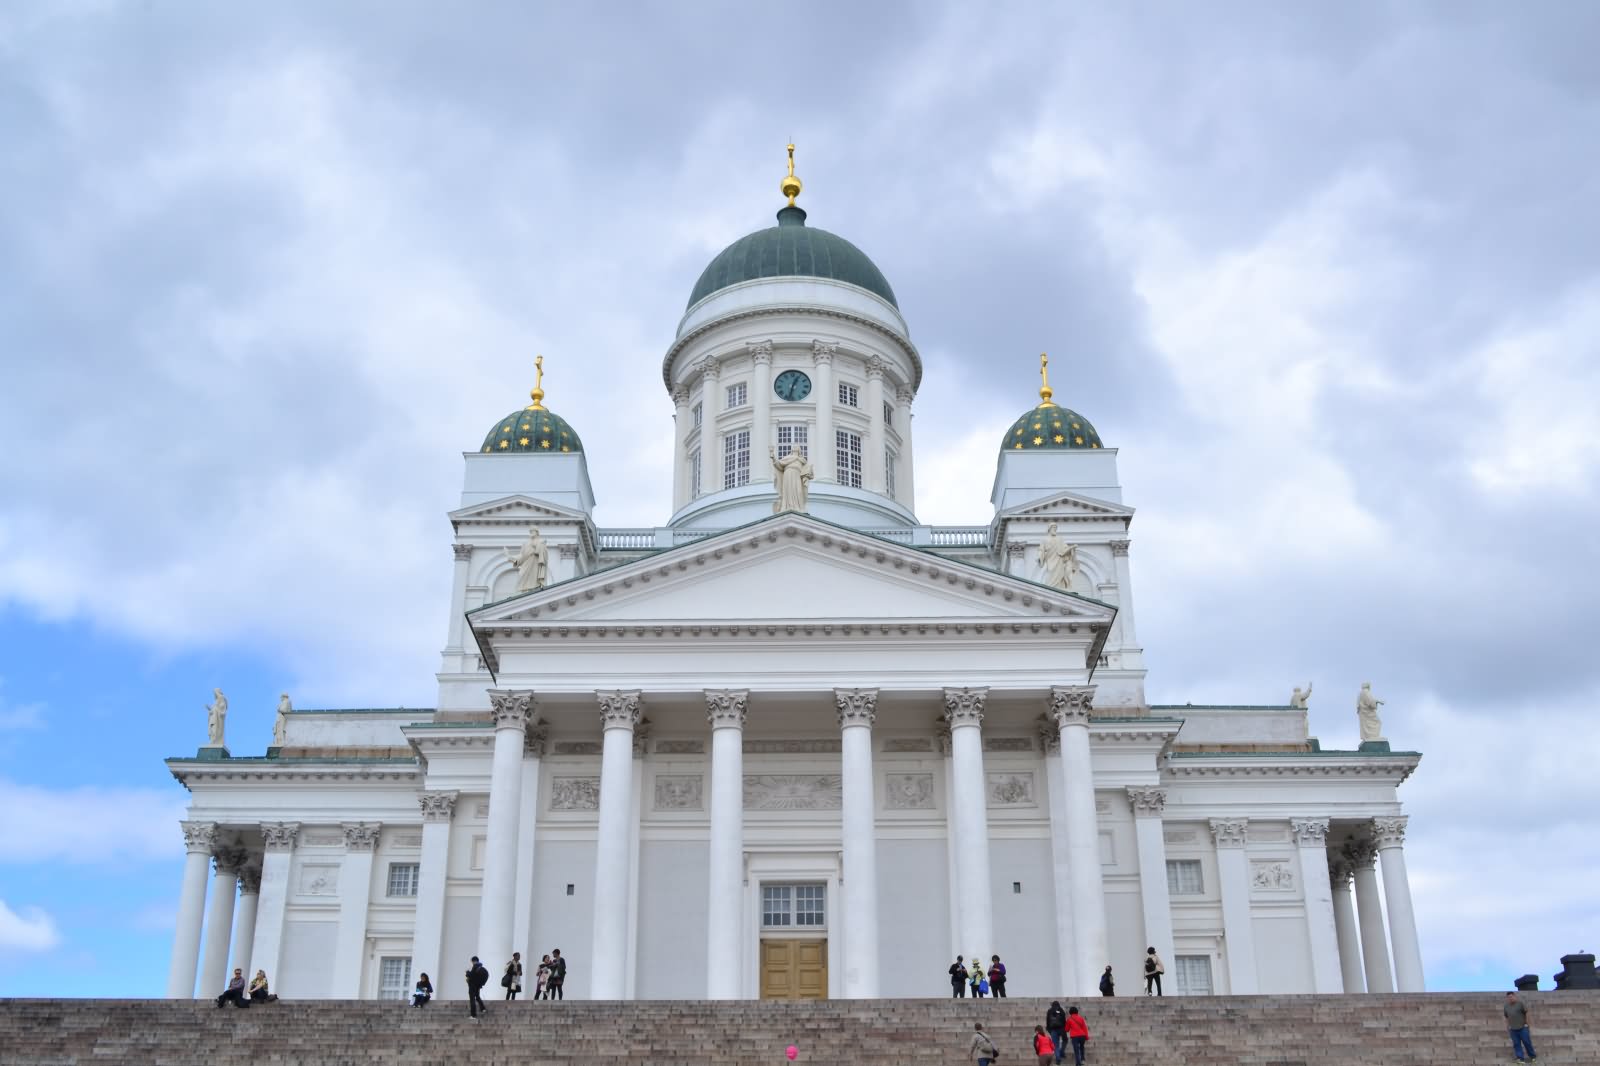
706,691,749,999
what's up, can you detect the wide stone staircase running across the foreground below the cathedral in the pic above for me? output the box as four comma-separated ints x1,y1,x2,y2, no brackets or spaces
0,992,1600,1066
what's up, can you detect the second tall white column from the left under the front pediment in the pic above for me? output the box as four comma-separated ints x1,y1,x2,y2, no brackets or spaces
589,691,638,999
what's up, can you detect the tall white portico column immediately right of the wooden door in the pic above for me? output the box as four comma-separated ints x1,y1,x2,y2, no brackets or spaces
834,688,878,999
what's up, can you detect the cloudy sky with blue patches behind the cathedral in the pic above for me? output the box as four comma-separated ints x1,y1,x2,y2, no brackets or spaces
0,0,1600,996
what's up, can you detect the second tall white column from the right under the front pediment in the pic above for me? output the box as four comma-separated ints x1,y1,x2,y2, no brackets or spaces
944,688,995,959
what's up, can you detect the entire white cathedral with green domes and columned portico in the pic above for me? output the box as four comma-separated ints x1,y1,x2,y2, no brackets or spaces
168,157,1422,999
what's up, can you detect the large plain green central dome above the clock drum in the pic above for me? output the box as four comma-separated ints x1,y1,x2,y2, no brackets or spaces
688,205,899,309
